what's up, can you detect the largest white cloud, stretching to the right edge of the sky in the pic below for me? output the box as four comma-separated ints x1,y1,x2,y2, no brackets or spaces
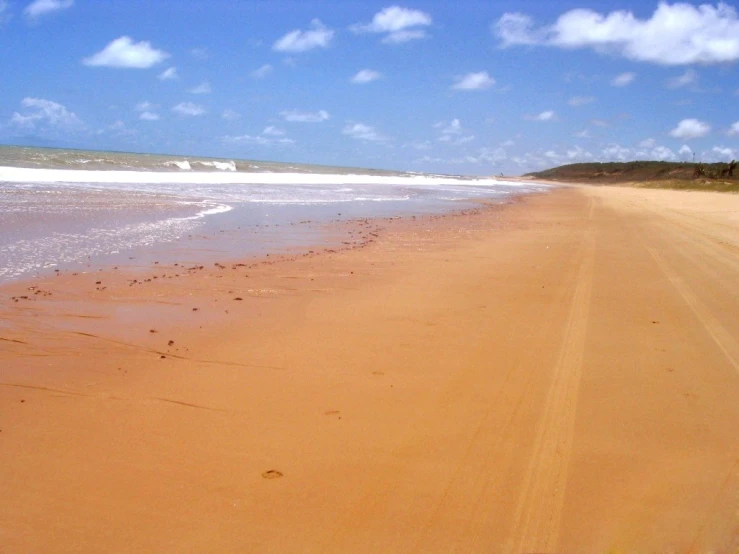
493,2,739,65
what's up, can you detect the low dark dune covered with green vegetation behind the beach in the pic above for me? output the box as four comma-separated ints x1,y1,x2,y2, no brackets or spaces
526,161,739,192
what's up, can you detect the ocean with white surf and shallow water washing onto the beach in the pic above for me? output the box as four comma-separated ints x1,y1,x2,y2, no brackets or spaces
0,146,547,283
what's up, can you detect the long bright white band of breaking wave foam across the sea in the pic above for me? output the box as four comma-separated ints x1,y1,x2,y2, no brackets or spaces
0,161,531,187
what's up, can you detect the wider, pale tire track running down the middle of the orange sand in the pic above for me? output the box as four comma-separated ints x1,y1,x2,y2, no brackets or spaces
506,223,595,552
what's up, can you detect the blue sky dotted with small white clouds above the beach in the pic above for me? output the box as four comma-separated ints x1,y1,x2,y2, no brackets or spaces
0,0,739,175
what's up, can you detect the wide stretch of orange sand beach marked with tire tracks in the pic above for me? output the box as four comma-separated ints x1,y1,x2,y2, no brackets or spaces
0,187,739,553
